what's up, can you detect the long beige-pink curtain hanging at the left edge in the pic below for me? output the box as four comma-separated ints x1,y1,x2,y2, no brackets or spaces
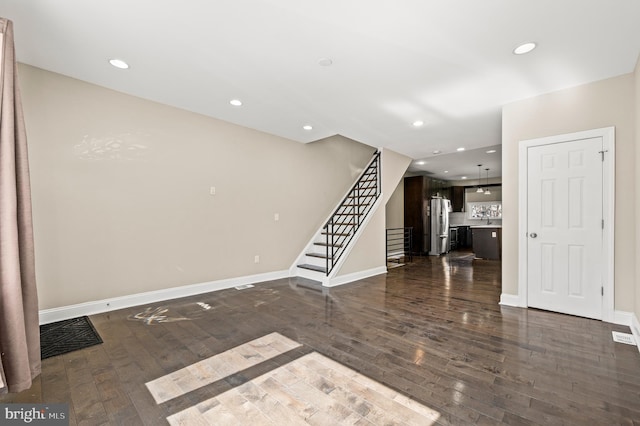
0,18,40,394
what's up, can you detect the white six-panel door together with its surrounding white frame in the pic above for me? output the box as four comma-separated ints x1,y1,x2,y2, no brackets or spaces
519,127,615,321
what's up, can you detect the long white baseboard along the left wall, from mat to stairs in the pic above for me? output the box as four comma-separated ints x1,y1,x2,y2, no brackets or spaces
40,271,289,324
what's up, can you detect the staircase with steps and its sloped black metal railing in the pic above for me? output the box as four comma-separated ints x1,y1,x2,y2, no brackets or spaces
296,152,382,282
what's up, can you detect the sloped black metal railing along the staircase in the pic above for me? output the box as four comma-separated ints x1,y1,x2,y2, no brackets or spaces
316,151,382,276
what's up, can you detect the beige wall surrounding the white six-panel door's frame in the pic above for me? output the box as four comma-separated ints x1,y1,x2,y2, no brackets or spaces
502,74,637,312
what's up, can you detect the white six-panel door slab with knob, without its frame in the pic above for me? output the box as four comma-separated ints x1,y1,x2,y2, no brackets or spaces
527,137,604,319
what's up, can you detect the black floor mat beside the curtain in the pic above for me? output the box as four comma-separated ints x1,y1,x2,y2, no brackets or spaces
40,316,102,359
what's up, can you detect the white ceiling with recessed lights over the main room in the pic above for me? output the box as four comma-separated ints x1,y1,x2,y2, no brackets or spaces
0,0,640,177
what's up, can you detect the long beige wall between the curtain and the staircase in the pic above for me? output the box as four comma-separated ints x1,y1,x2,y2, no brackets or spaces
19,65,383,309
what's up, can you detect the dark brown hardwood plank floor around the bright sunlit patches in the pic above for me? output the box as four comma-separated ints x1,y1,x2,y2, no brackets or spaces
0,256,640,425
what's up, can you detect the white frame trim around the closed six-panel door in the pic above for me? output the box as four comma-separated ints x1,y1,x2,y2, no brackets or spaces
518,127,616,322
